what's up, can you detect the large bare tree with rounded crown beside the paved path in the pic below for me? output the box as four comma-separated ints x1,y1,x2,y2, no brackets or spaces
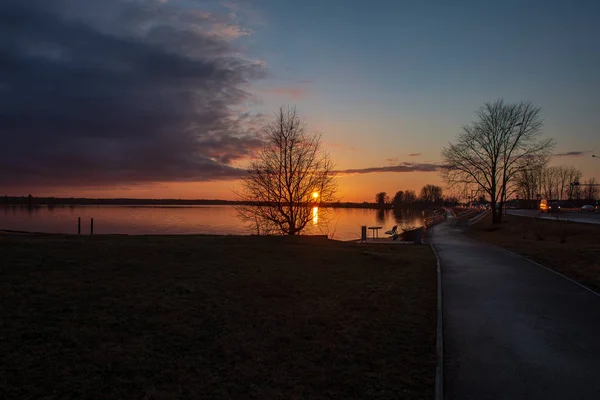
442,99,553,224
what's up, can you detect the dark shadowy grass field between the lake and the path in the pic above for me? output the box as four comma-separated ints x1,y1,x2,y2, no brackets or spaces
0,235,436,399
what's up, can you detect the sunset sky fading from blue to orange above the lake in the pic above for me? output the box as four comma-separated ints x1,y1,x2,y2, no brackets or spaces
0,0,600,201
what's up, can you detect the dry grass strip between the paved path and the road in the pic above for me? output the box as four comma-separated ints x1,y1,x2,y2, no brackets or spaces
466,215,600,292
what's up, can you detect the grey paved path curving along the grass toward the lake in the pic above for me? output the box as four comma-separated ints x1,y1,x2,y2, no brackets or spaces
433,218,600,400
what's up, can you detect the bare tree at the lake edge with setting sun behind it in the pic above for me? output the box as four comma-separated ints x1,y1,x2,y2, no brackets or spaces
237,107,337,235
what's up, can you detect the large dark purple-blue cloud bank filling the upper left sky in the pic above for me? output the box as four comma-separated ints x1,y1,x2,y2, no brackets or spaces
0,0,265,185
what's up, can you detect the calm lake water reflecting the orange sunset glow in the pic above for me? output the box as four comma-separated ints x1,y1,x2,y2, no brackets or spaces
0,206,422,240
